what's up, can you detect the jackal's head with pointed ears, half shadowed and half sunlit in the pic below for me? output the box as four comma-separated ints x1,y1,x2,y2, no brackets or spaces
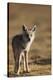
23,25,36,42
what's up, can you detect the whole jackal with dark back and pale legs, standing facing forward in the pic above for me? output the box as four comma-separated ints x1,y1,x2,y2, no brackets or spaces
12,25,36,75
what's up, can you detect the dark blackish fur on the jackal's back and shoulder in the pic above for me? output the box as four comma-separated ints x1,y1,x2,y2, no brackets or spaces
12,34,26,49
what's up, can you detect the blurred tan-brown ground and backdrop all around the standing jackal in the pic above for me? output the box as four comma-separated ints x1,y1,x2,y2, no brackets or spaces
7,3,51,77
